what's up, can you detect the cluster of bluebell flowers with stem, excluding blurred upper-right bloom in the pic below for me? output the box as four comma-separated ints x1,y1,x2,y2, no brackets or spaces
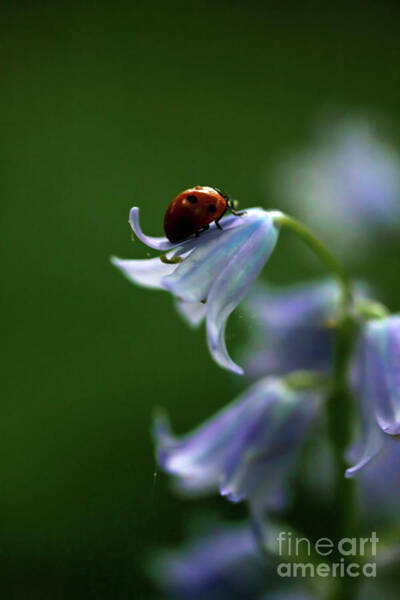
112,157,400,599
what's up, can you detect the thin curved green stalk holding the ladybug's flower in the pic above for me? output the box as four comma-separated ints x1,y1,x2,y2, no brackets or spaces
273,211,352,307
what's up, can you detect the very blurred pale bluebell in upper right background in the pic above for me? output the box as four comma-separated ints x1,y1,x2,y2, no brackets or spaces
274,118,400,259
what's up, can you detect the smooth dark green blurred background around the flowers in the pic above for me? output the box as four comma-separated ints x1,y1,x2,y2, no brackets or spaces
0,0,400,600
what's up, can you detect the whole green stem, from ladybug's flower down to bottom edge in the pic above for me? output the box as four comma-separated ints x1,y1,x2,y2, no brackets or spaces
273,211,357,600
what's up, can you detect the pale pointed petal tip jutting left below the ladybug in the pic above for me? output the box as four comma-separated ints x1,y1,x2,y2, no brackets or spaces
111,256,176,289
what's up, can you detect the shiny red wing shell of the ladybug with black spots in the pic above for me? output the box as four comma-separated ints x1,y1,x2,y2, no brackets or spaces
164,185,227,242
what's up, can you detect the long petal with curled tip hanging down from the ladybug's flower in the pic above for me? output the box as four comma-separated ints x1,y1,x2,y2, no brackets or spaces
207,213,278,375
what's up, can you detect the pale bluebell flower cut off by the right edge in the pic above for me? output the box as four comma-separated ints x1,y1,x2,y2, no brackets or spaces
346,315,400,477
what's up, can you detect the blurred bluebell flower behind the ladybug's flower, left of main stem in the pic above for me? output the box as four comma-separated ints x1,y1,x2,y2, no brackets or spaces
242,279,340,377
